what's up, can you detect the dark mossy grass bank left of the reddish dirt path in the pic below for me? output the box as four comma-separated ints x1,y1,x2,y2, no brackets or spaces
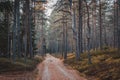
0,57,42,74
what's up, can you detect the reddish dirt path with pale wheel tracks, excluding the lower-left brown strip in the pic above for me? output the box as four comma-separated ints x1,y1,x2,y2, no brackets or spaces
36,54,86,80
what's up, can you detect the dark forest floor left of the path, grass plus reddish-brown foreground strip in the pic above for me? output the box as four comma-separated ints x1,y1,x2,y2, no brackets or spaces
0,56,42,80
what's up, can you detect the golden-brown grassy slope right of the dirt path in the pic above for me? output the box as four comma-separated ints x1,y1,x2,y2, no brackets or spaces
64,49,120,80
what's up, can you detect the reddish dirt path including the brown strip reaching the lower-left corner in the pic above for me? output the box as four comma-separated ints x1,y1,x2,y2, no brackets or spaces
0,54,87,80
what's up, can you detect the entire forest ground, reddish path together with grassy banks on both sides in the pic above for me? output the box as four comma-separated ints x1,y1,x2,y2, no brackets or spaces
0,49,120,80
